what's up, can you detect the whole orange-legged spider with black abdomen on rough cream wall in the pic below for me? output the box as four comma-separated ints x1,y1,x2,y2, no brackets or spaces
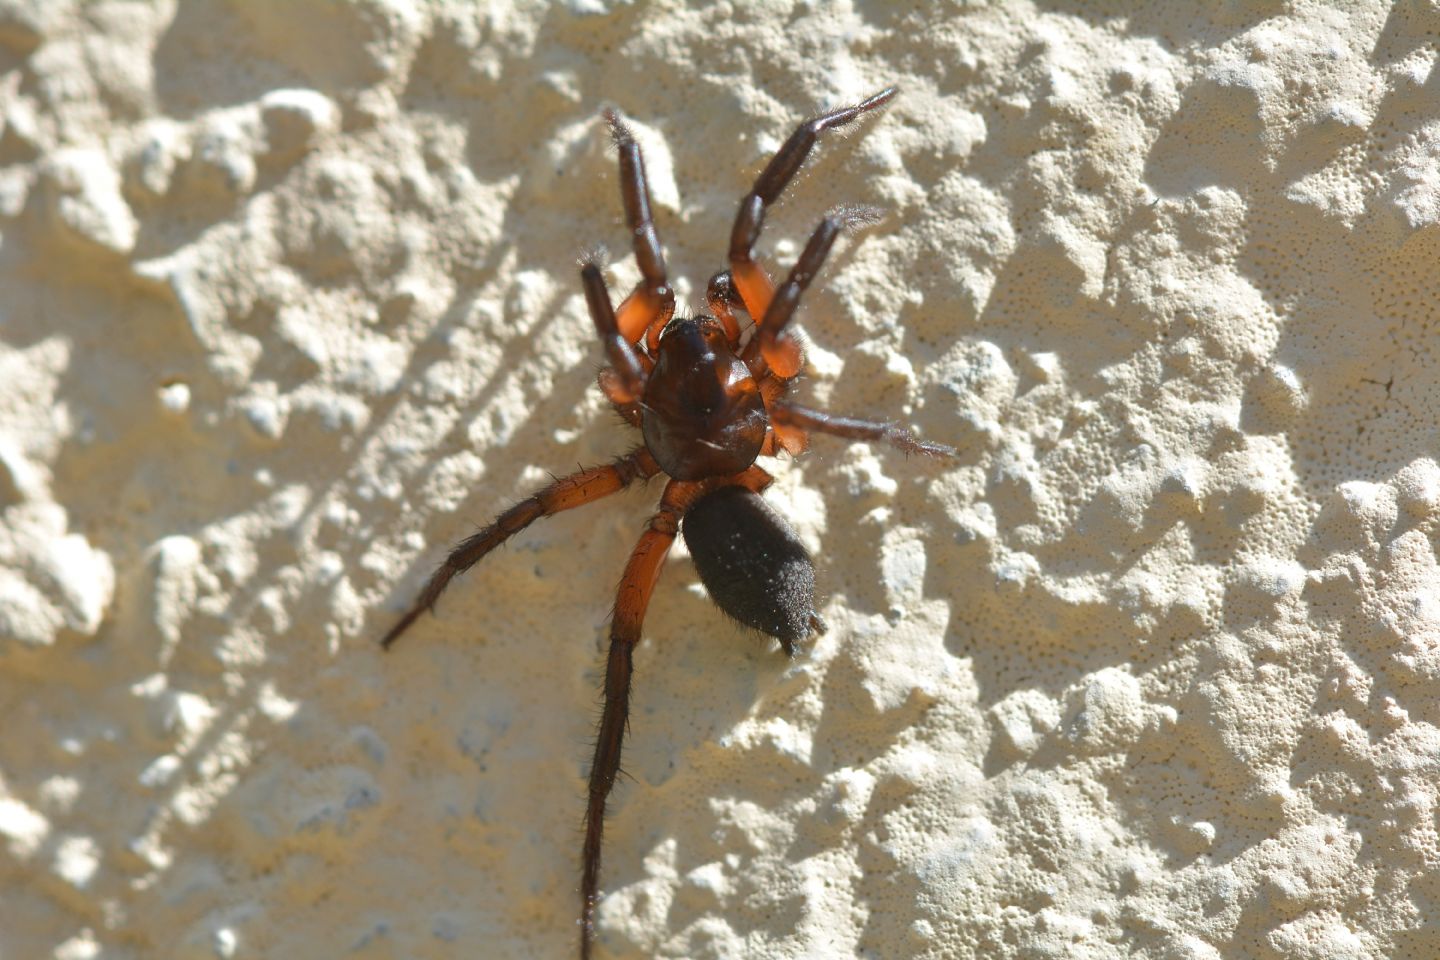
382,86,955,960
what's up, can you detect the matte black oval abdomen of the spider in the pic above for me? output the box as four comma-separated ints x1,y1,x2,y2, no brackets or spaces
681,486,819,653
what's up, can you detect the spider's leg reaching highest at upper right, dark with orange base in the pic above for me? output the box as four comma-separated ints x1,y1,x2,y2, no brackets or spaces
730,86,897,318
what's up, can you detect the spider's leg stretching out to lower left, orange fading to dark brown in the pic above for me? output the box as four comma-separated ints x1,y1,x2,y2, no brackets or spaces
380,449,660,648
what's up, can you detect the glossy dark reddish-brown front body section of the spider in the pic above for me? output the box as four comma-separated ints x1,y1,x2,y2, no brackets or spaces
641,317,769,481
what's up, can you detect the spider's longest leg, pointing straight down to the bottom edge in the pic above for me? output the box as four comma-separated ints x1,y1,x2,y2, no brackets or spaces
580,481,703,960
